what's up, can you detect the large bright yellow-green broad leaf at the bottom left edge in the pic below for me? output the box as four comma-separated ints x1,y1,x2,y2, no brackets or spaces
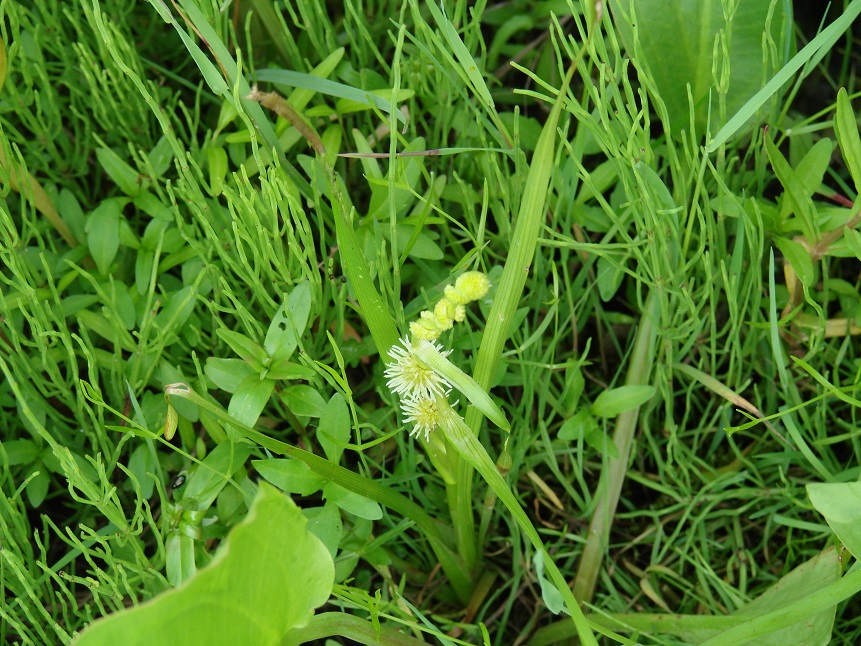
76,483,335,646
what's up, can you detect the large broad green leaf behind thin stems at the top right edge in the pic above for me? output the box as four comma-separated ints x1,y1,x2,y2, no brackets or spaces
610,0,792,137
